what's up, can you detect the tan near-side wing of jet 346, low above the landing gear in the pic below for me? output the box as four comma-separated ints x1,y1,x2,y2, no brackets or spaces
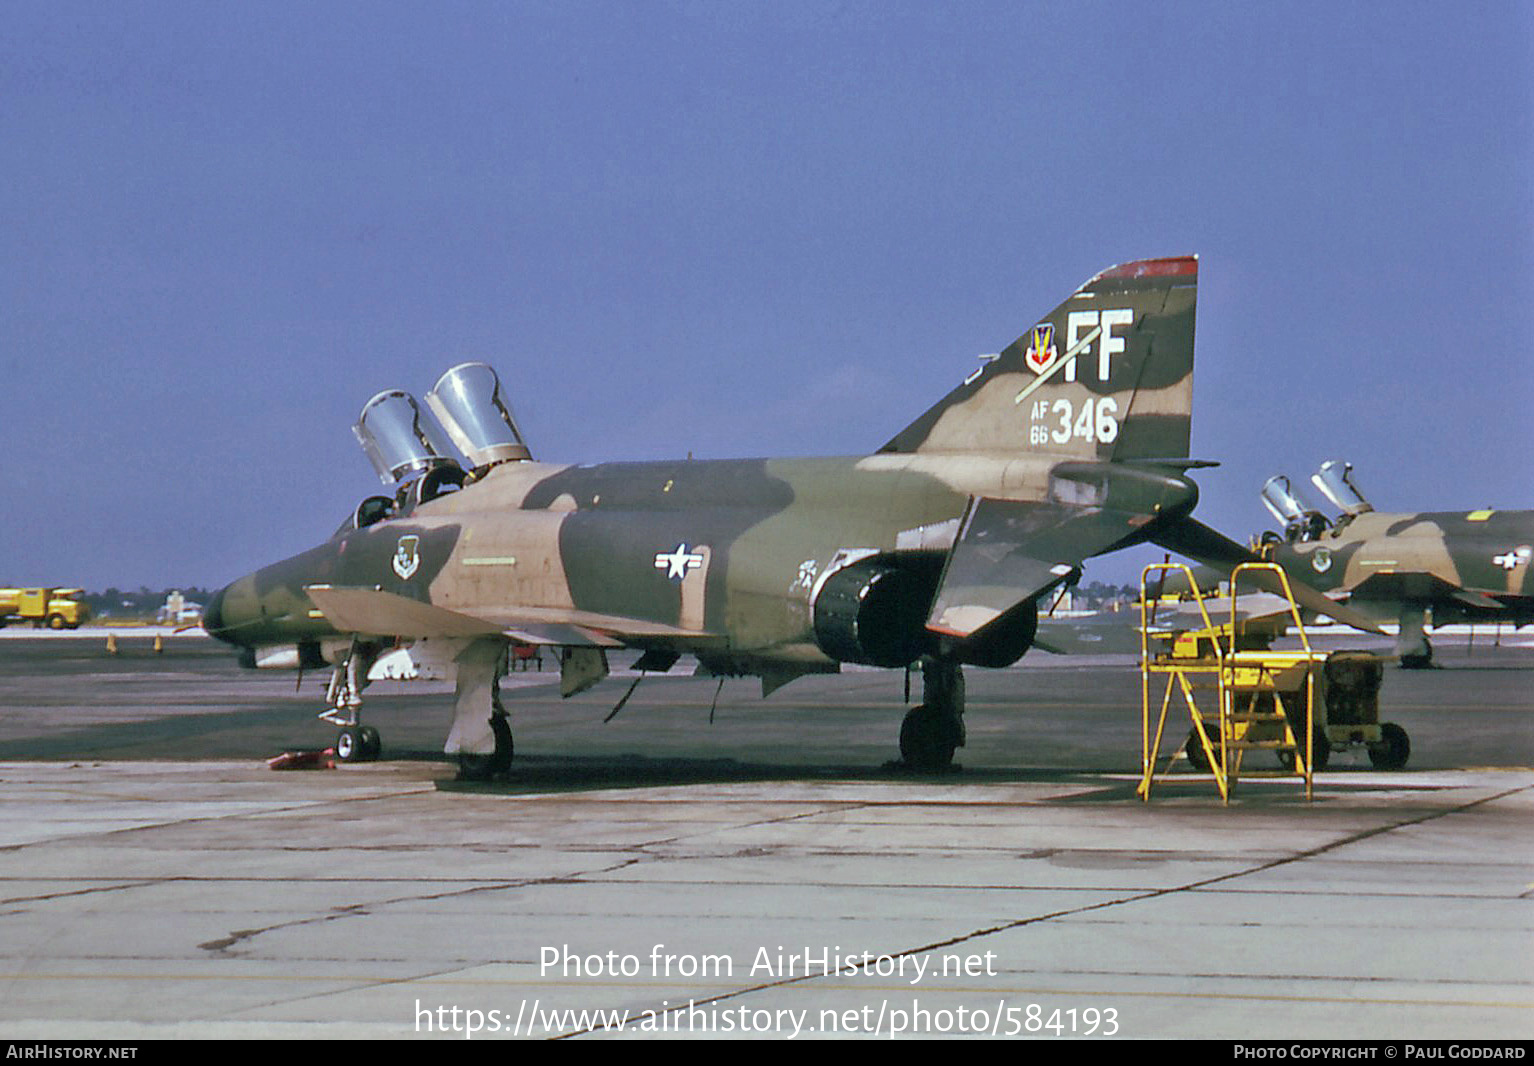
304,584,707,647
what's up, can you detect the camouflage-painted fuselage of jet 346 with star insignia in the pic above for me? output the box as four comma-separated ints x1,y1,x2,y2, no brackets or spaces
210,454,1192,661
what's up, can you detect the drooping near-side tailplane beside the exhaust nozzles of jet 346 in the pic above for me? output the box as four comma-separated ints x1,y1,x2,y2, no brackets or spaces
927,497,1144,637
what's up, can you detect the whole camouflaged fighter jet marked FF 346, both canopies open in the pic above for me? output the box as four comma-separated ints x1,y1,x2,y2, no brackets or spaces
204,258,1368,776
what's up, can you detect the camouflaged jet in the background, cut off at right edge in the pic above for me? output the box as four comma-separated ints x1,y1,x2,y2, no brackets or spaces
1262,460,1534,667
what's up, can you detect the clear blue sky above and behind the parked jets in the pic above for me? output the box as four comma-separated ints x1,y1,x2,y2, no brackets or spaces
0,0,1534,589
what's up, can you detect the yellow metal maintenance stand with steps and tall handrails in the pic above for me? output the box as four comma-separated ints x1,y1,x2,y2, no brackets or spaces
1135,563,1327,804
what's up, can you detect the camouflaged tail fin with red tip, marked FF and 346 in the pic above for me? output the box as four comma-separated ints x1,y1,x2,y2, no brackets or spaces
881,256,1198,460
